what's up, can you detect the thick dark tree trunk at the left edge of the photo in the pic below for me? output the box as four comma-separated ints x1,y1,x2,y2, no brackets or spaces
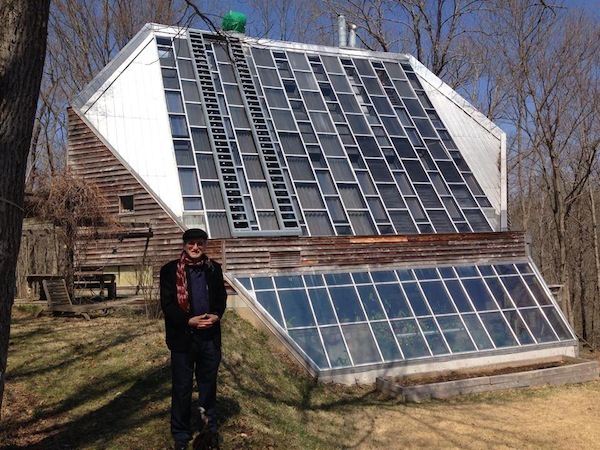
0,0,50,414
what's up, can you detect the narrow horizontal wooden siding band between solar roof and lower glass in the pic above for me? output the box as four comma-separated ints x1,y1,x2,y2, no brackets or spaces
217,232,527,273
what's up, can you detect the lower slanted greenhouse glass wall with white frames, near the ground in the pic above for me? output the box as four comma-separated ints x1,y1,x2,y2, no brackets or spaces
236,262,575,370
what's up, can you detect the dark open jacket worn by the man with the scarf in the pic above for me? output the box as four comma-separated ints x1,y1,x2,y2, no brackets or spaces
160,259,227,352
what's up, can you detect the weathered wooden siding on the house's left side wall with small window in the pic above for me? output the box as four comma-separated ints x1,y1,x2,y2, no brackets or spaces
68,109,190,283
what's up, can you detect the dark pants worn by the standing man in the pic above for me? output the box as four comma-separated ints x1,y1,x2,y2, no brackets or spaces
171,336,221,441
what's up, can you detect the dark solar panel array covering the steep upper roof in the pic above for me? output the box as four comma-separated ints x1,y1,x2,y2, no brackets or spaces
157,32,492,238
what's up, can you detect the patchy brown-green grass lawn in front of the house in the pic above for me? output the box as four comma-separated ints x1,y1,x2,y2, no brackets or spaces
0,308,600,450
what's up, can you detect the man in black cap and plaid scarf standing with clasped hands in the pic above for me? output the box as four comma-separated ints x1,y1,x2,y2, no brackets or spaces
160,228,227,450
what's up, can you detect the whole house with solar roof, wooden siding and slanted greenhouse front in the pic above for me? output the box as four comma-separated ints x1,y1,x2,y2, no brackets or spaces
69,24,577,382
